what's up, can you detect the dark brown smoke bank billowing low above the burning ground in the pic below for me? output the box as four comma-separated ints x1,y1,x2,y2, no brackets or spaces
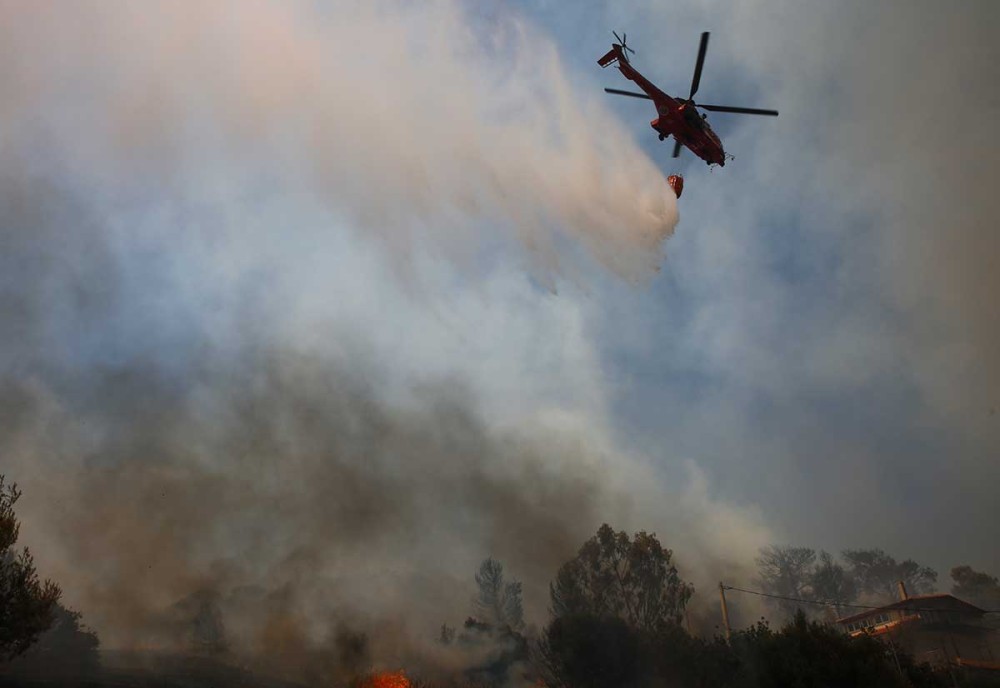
2,322,767,667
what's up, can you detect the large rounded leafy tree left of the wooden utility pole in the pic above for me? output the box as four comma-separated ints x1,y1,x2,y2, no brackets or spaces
549,523,694,631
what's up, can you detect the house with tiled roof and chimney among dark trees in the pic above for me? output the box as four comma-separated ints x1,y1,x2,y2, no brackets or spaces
837,583,1000,670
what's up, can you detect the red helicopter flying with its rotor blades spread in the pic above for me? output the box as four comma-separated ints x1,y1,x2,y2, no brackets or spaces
597,31,778,166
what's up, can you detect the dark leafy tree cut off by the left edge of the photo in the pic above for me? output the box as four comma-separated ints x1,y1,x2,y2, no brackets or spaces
0,475,62,661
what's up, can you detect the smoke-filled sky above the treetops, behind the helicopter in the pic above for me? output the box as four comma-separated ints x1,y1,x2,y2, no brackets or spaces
0,0,1000,672
